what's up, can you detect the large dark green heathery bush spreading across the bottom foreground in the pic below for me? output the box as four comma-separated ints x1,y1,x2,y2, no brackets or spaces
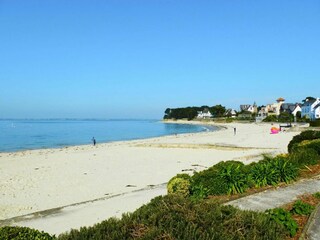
59,195,286,240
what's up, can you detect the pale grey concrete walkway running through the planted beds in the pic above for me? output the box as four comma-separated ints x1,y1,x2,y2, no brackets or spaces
226,176,320,240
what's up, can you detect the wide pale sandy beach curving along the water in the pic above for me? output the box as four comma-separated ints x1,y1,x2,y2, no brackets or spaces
0,123,299,234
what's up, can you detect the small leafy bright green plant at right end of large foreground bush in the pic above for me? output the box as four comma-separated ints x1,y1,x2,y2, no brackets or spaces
266,208,298,237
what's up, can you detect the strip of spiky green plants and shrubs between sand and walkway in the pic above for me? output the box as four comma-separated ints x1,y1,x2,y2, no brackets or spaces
168,154,302,199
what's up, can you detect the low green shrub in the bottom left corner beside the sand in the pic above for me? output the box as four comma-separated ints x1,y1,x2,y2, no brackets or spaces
0,226,56,240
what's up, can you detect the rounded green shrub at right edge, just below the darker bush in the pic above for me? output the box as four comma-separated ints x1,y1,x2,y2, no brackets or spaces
289,148,319,167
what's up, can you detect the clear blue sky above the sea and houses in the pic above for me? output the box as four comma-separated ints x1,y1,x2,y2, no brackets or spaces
0,0,320,118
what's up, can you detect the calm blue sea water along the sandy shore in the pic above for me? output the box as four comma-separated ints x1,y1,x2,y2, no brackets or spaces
0,120,217,152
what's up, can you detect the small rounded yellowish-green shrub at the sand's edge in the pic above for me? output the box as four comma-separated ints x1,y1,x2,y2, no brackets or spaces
167,174,190,197
